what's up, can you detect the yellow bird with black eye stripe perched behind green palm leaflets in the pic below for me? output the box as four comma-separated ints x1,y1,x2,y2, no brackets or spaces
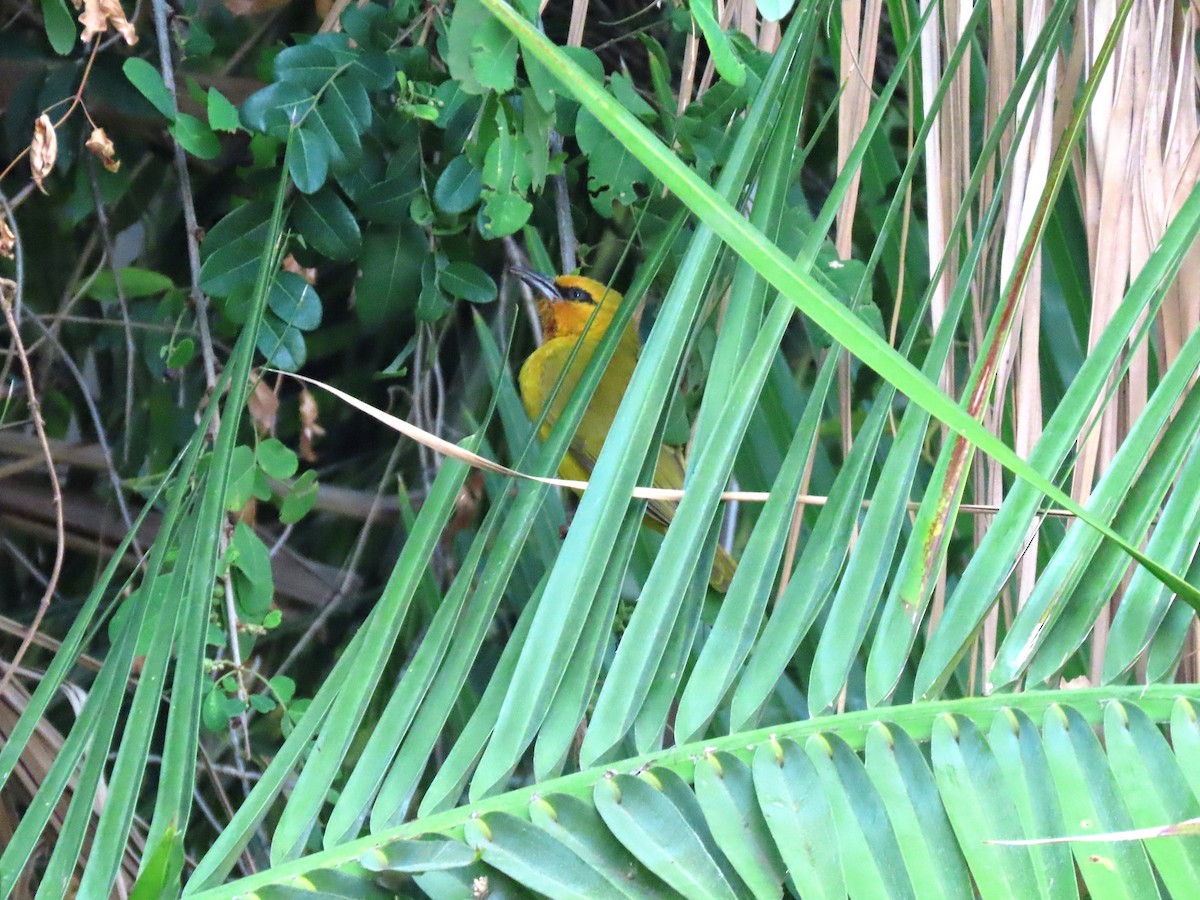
514,269,737,594
